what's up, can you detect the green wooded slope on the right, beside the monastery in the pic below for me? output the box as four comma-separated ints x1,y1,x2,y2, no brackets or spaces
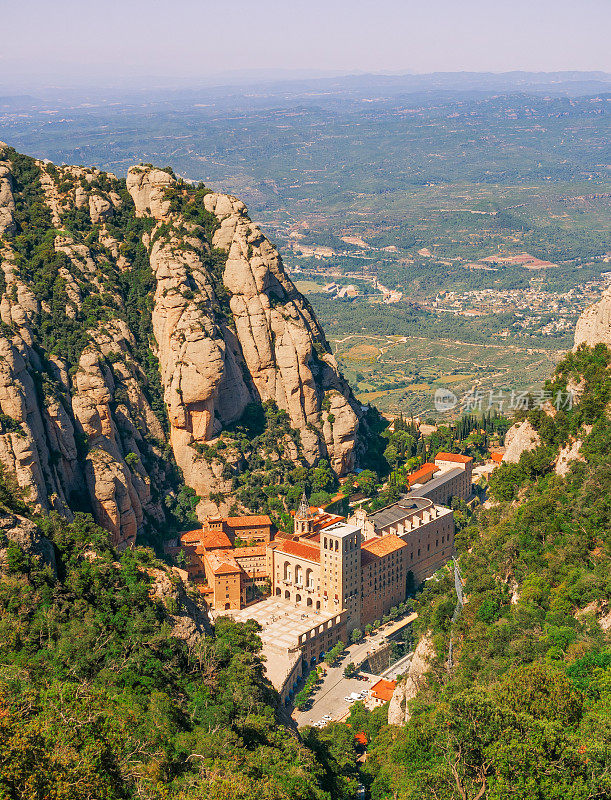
309,344,611,800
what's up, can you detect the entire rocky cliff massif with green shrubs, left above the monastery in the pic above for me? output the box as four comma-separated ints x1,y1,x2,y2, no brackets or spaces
0,144,364,545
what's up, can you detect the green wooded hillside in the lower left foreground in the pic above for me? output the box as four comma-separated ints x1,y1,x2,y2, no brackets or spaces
0,496,355,800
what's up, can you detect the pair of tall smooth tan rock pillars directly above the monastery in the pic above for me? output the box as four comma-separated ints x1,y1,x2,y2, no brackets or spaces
127,167,360,495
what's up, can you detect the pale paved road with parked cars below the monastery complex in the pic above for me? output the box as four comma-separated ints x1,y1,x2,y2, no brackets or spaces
293,615,415,727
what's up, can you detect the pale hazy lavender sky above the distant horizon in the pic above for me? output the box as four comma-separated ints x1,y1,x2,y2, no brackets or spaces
0,0,611,84
